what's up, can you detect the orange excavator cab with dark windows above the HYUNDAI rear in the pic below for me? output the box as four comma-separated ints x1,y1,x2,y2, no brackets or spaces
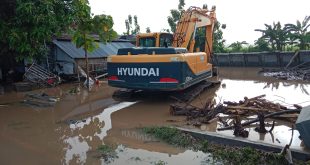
136,32,173,47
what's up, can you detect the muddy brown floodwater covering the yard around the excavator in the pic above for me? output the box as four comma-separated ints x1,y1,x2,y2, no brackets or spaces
0,68,310,164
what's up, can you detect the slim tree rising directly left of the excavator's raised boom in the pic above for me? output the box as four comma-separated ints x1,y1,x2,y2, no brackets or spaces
167,0,185,33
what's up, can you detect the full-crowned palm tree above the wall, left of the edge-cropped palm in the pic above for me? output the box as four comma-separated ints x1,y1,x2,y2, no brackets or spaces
255,22,287,51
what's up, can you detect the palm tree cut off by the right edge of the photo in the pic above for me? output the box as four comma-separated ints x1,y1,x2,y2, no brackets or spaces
285,16,310,49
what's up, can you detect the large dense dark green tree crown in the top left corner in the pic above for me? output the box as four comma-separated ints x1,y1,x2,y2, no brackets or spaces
0,0,80,60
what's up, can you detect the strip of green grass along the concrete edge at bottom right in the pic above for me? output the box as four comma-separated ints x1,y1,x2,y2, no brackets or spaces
143,127,300,165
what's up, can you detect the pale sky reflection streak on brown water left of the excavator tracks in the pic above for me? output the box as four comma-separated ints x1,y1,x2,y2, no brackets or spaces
61,102,136,163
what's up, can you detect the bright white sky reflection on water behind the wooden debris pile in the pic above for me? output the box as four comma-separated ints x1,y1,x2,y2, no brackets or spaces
216,79,310,106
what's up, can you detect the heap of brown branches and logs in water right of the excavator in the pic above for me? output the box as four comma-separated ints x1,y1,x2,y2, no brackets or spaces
170,95,302,137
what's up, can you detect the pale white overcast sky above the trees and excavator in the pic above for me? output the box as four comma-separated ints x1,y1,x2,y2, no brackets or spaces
89,0,310,44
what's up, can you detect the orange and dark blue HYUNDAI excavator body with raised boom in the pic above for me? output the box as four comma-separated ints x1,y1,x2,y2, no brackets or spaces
108,7,216,91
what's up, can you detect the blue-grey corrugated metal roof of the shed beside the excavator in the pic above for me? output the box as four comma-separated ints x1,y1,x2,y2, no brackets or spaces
53,40,134,58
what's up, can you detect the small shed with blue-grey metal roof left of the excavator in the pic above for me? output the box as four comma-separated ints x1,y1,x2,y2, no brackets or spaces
49,40,134,75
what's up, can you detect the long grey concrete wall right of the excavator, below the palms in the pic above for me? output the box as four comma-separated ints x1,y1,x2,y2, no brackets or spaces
213,50,310,67
